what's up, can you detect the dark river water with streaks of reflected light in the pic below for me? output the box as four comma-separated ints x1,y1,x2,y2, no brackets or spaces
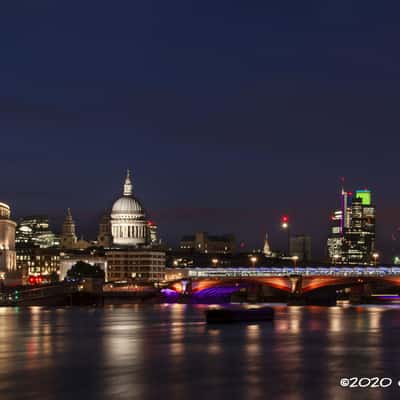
0,304,400,400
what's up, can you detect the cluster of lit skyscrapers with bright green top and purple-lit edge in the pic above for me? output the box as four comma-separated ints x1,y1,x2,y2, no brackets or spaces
327,189,376,264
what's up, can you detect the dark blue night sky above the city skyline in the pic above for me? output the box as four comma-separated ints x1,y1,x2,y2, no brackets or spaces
0,0,400,257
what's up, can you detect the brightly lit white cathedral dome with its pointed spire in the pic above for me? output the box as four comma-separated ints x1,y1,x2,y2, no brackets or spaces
111,170,149,246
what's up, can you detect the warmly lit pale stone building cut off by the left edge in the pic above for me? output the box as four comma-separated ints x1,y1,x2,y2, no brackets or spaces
0,203,17,273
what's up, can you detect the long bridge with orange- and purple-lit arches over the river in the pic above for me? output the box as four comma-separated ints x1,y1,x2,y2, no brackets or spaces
164,266,400,298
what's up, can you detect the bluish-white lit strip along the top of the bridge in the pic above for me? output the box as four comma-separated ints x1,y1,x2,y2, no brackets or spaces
187,266,400,279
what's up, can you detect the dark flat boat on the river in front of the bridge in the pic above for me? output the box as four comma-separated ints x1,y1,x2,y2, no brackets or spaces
206,306,274,324
